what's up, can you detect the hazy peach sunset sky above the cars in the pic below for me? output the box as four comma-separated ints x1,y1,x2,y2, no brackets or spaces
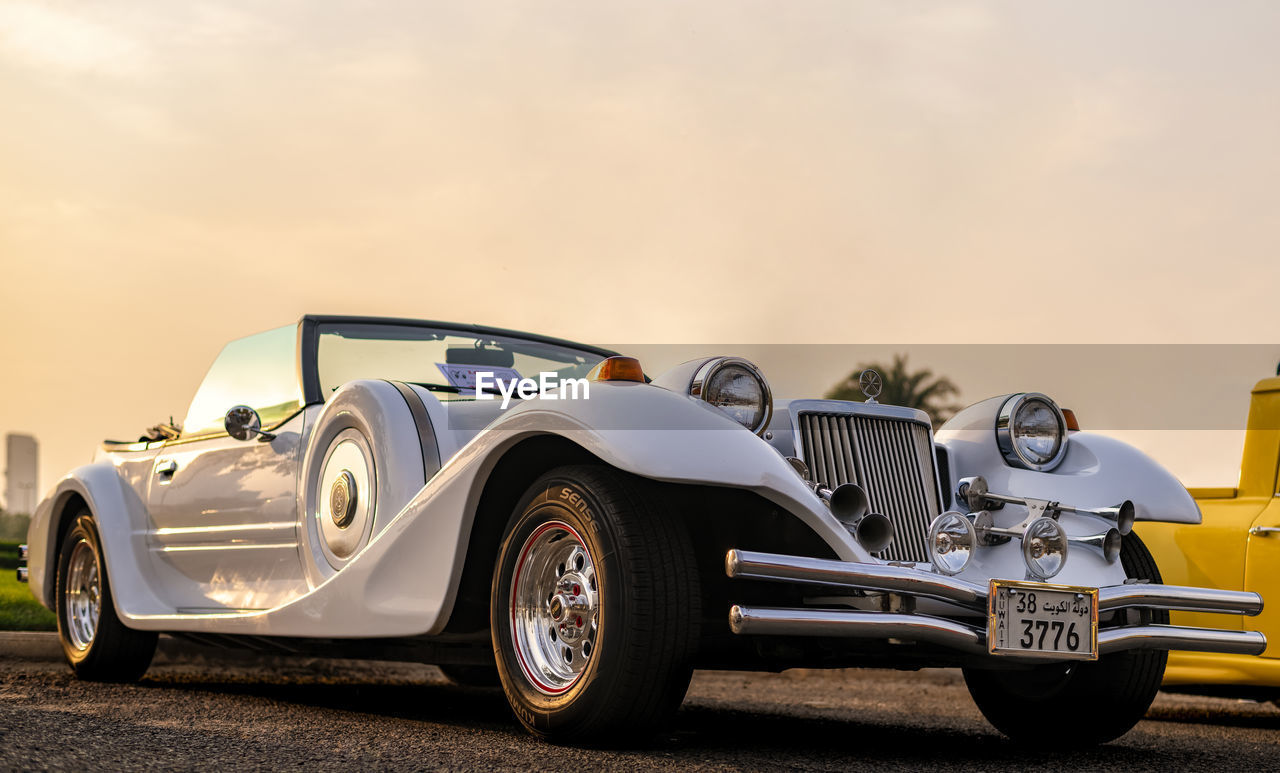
0,0,1280,486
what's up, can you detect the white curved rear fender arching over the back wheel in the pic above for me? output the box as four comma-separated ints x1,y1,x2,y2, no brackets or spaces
27,461,168,617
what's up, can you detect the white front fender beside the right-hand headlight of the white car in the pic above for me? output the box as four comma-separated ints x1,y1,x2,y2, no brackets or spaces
936,395,1201,523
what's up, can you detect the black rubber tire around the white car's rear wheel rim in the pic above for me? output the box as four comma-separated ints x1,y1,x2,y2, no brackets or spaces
55,509,159,682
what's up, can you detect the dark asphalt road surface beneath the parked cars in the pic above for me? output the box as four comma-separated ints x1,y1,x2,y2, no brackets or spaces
0,658,1280,772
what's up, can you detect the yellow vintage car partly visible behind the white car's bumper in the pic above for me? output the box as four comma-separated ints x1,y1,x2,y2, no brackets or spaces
1135,378,1280,700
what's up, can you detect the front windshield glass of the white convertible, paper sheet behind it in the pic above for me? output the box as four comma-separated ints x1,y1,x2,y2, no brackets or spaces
316,323,604,399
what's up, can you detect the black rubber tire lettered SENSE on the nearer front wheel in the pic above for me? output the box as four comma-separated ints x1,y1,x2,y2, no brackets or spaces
489,465,701,744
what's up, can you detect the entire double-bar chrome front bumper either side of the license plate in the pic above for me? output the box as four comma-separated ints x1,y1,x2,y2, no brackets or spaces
724,550,1267,655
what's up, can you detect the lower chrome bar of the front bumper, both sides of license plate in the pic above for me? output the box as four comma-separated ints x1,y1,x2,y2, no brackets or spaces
728,604,1267,655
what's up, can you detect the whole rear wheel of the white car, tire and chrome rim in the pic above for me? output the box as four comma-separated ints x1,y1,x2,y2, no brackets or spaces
56,511,157,682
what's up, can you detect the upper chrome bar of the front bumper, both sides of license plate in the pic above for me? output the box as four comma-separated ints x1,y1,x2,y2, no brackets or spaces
724,550,1262,614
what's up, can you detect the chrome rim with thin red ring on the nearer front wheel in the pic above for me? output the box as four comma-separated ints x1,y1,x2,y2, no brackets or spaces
511,521,600,695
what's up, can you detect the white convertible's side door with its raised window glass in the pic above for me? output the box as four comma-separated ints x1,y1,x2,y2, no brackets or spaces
147,325,306,612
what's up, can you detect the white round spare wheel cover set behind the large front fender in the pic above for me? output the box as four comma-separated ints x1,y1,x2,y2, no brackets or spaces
298,380,426,586
